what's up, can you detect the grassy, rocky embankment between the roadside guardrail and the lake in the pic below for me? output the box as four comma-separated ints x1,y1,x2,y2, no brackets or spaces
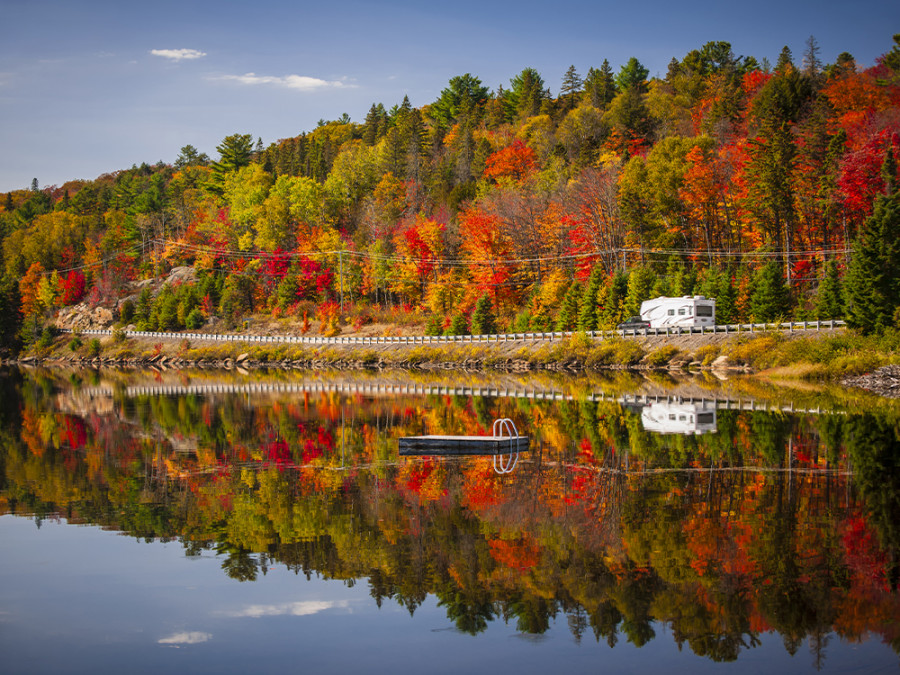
29,320,900,381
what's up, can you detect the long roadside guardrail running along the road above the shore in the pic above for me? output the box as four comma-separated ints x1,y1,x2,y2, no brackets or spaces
60,320,847,345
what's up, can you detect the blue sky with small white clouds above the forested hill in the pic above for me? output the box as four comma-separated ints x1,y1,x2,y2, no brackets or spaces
0,0,900,192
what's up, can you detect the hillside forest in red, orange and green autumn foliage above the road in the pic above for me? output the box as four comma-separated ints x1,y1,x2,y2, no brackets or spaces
0,35,900,349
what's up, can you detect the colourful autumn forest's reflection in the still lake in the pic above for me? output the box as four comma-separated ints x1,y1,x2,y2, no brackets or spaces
0,373,900,662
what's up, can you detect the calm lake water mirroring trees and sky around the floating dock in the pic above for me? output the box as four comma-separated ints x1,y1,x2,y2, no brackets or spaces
0,370,900,673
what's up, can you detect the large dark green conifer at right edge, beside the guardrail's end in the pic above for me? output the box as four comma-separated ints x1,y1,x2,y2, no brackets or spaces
845,193,900,334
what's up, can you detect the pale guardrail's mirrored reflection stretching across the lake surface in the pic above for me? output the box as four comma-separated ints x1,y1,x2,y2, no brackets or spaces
79,382,832,415
